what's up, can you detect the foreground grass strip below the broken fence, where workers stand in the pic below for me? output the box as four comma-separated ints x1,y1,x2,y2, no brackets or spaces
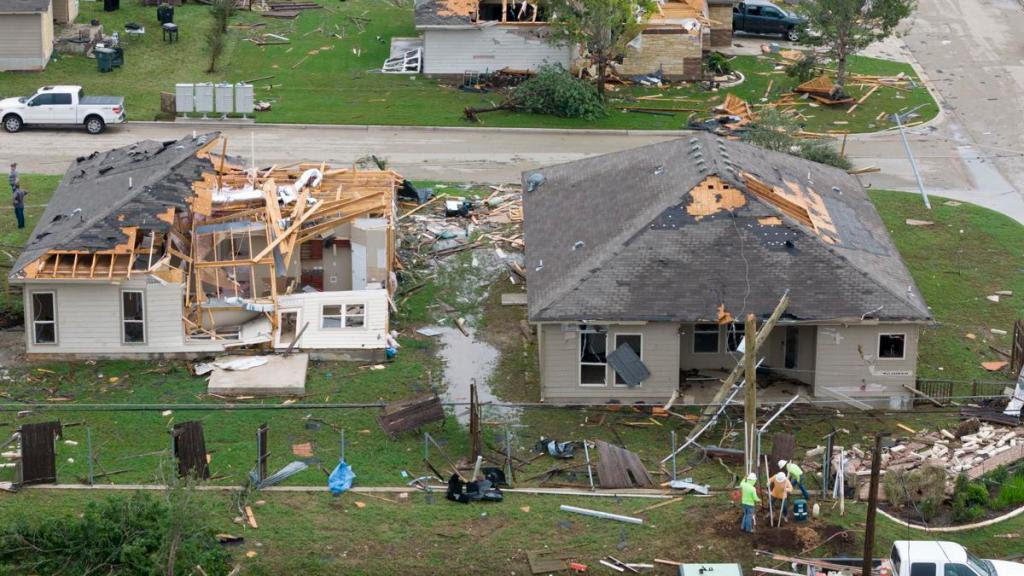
0,481,1024,576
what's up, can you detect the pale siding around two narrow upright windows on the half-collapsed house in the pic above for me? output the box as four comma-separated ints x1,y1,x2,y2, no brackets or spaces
25,280,222,356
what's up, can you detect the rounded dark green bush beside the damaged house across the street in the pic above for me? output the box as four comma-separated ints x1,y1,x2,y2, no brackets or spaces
512,66,605,120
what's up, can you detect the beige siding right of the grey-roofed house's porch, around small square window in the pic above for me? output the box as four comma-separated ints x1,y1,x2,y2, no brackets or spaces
814,324,919,408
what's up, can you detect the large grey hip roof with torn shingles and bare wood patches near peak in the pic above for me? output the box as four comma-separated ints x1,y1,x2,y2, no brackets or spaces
523,132,931,322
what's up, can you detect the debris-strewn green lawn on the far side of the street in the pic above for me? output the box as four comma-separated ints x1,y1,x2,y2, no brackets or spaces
0,0,938,132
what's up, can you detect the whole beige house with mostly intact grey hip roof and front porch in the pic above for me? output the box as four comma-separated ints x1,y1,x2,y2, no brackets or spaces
523,132,932,408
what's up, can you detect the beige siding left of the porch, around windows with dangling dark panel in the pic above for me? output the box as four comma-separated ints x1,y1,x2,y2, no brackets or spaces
540,323,679,404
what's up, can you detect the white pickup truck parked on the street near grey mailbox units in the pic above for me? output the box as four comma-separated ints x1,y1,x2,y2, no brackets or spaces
0,86,125,134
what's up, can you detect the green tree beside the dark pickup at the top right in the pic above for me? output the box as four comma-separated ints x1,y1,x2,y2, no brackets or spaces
798,0,916,91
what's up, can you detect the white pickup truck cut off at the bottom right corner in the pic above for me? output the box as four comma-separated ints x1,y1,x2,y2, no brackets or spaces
807,540,1024,576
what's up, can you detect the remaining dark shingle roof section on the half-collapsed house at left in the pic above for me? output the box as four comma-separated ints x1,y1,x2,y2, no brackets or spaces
11,132,218,276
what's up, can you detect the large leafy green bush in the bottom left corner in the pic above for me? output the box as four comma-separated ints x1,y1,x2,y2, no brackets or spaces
0,490,230,576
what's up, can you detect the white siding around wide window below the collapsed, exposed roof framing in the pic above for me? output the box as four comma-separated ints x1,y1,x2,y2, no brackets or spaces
278,290,388,349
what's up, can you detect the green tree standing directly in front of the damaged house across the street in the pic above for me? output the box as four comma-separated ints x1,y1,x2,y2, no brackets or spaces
550,0,657,100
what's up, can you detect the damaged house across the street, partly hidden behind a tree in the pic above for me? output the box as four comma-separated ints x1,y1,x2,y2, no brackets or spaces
415,0,732,80
